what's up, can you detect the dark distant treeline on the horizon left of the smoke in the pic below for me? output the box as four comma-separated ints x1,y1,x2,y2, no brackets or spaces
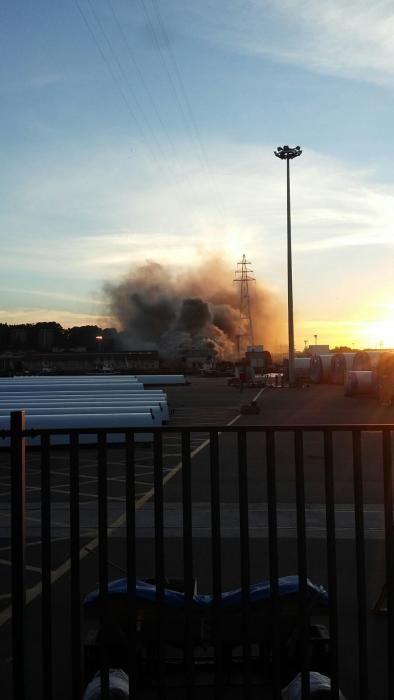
0,322,124,353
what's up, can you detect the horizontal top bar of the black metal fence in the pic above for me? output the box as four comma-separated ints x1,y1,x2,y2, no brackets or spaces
0,423,394,439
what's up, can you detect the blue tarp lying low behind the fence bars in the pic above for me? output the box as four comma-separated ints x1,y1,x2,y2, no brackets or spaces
84,576,328,608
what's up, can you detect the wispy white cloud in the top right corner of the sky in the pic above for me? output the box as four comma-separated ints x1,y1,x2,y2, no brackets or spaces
185,0,394,82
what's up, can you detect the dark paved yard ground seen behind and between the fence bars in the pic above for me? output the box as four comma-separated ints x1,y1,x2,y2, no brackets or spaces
0,378,394,700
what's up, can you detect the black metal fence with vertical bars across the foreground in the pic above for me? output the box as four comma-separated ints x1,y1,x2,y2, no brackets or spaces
0,412,394,700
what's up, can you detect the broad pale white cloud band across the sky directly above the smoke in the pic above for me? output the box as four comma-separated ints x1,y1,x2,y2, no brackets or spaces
0,141,394,334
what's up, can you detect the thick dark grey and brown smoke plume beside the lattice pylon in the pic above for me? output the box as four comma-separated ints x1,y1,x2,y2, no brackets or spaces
105,259,282,359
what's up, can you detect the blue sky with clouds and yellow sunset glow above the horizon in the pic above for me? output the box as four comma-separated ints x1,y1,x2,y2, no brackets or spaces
0,0,394,348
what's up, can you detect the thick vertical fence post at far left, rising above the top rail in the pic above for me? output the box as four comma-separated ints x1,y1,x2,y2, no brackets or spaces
10,411,26,700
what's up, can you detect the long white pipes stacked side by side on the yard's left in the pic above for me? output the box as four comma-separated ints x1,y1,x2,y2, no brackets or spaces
0,375,169,444
